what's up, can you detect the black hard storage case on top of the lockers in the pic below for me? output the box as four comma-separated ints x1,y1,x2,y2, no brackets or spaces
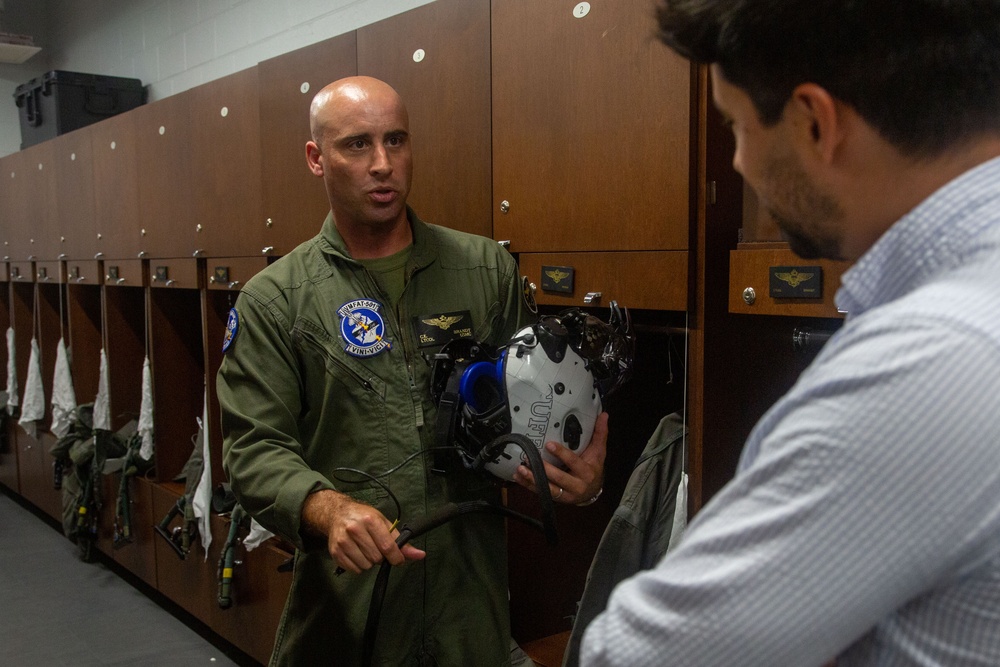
14,70,146,148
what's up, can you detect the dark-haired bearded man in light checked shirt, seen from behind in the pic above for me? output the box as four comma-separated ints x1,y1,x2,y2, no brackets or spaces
582,0,1000,667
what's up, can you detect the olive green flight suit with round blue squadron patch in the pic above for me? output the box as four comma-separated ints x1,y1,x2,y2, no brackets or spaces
218,210,527,667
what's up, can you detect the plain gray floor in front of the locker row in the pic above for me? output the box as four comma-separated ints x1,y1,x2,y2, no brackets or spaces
0,490,246,667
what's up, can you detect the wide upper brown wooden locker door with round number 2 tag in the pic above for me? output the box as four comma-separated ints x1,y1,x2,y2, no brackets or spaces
492,0,692,253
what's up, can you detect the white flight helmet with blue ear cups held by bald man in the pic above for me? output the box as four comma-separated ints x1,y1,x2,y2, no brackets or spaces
431,302,634,481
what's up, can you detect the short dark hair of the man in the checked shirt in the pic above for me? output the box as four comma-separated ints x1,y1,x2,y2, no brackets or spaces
657,0,1000,156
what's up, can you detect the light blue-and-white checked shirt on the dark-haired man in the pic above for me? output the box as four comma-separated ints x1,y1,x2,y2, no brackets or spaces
582,158,1000,667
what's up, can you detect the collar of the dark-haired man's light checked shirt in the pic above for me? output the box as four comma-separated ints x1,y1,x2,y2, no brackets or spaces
836,157,1000,316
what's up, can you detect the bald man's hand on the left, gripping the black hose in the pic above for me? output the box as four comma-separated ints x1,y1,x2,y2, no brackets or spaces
302,489,427,574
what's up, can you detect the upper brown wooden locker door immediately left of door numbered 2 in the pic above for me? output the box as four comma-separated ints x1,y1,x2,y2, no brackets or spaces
358,0,493,236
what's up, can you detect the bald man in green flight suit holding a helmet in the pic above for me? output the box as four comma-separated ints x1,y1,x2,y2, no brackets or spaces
218,77,606,667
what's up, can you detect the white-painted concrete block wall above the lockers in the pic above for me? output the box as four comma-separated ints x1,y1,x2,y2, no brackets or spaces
0,0,433,156
